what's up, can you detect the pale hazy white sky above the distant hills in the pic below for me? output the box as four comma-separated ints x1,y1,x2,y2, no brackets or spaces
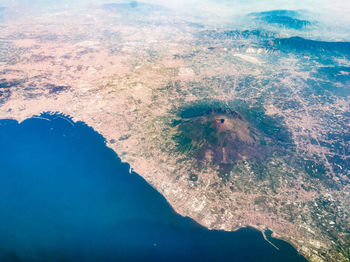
0,0,350,41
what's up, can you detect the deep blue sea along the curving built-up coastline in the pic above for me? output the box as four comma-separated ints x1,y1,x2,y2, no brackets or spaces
0,115,303,261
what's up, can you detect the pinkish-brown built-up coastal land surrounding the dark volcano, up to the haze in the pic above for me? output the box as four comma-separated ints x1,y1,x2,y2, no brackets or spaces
0,4,350,261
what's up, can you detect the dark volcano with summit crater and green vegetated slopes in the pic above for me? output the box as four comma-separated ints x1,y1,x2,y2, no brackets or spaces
170,100,294,164
